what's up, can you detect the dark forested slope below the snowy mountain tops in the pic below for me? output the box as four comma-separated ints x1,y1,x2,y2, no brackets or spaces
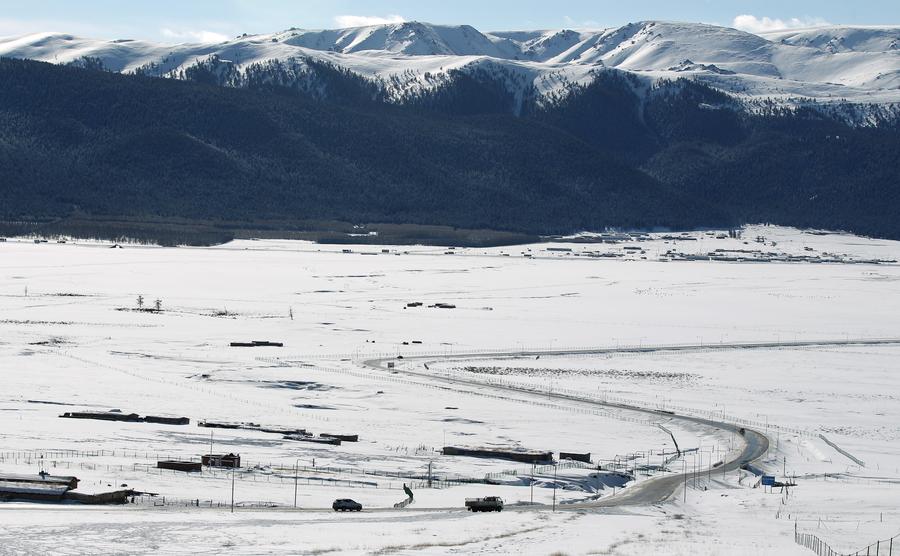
0,59,900,243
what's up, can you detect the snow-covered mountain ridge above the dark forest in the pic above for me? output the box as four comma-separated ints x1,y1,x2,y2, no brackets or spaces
0,21,900,115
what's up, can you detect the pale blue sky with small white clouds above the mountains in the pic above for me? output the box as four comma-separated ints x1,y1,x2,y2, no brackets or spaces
0,0,900,42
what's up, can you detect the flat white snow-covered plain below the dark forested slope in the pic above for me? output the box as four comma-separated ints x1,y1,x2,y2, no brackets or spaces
0,227,900,554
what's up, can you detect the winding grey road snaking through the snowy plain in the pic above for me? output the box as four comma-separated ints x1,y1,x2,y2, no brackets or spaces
363,346,788,510
